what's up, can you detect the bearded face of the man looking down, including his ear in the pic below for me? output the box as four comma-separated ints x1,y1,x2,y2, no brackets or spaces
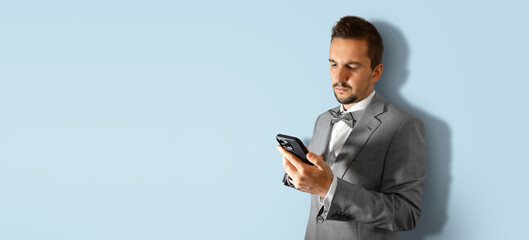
329,38,383,109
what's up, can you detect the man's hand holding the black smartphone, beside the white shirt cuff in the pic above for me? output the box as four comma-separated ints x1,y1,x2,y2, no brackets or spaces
276,146,334,197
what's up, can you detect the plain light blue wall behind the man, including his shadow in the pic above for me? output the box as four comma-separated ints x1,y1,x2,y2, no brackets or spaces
0,0,529,240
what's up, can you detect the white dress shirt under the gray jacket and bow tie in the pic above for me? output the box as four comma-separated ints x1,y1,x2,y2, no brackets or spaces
320,90,375,211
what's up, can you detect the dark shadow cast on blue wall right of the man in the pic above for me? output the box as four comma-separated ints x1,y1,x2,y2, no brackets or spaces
373,21,452,240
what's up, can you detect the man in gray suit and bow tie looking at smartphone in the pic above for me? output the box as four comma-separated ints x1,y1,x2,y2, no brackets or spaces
277,16,425,239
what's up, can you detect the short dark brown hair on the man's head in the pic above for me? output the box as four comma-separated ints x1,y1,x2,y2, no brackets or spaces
331,16,384,69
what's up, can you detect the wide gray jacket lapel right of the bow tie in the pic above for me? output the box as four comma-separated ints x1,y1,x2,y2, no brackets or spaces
329,94,386,178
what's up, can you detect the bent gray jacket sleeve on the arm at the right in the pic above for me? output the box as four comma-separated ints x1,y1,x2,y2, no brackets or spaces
323,117,425,231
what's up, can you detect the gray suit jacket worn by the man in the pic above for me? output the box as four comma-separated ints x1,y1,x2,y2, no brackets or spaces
305,94,425,240
